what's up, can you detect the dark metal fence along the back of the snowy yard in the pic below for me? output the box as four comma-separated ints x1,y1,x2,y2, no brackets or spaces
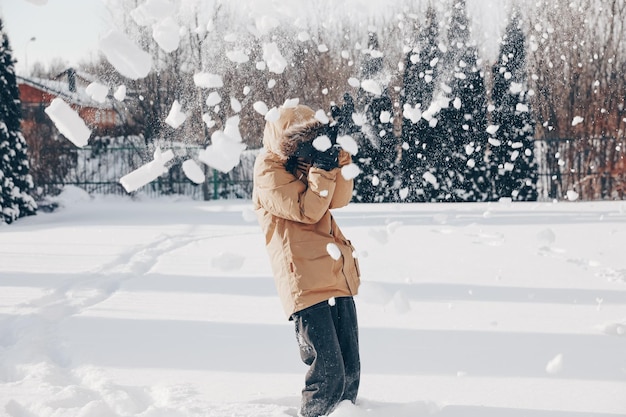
36,138,626,201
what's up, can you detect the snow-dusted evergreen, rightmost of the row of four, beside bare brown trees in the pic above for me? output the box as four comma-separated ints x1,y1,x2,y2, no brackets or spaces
489,11,537,201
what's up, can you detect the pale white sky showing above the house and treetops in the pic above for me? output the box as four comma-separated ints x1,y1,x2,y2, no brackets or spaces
0,0,510,75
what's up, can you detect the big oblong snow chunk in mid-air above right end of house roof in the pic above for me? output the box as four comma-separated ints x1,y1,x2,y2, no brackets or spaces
99,30,152,80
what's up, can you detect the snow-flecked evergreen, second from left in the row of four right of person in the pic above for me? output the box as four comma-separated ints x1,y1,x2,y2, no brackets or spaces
400,6,442,201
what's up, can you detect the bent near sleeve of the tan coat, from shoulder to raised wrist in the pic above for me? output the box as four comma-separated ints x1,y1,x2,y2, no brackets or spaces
254,154,341,224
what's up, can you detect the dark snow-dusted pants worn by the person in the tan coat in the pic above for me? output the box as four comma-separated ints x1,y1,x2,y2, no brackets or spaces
292,297,361,417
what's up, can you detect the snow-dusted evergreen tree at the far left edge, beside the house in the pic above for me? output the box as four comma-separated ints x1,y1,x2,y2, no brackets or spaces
0,19,37,223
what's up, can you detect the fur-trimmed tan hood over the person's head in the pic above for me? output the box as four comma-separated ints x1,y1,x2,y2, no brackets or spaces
263,104,322,161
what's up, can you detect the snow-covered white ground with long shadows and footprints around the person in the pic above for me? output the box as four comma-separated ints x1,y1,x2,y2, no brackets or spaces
0,190,626,417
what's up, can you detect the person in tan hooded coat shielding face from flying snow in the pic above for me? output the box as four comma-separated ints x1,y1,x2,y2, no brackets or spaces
252,101,360,417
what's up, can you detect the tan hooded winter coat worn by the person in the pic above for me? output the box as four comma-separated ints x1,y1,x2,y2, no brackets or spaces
252,105,360,317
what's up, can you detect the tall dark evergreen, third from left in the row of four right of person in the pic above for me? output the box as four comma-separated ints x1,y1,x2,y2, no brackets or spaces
429,0,489,201
